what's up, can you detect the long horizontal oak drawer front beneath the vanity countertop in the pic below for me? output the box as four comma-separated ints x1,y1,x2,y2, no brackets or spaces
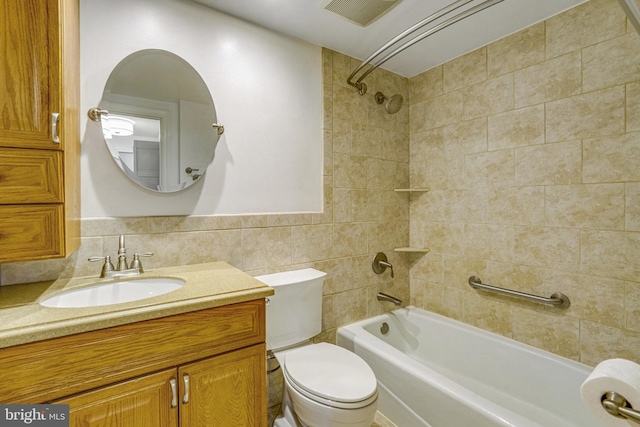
0,298,265,403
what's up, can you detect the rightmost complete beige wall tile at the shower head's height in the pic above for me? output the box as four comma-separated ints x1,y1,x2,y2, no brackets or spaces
545,86,625,142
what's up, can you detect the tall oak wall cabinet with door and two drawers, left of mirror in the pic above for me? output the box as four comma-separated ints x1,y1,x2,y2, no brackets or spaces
0,0,80,263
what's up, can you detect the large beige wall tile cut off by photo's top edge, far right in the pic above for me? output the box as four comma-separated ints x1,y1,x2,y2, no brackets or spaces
546,0,626,58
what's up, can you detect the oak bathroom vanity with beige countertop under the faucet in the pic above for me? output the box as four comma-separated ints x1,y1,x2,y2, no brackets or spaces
0,263,273,427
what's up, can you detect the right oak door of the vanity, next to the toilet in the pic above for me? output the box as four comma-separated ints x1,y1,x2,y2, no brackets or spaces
178,344,267,427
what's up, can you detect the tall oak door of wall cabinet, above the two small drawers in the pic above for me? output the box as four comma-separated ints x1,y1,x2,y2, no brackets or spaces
0,0,61,149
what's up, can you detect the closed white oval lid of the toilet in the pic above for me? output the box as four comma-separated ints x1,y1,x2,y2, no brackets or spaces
284,343,377,403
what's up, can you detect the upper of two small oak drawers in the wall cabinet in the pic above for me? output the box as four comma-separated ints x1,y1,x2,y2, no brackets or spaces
0,148,62,204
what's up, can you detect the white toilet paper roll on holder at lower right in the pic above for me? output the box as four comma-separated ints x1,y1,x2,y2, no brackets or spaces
580,359,640,427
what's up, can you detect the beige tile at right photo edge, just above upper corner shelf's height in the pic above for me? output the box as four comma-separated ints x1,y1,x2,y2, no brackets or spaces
583,132,640,182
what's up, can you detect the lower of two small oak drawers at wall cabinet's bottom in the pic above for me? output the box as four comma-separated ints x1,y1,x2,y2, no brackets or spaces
0,204,64,263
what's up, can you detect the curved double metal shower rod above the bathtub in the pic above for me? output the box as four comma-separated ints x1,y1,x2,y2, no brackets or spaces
347,0,504,95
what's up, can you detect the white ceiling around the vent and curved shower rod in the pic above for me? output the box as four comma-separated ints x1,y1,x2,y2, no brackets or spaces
194,0,586,77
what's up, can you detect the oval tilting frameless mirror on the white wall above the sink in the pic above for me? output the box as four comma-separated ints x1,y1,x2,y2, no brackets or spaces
89,49,223,192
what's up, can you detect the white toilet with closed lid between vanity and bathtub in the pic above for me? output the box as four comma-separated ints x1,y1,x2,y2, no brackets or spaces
256,268,378,427
